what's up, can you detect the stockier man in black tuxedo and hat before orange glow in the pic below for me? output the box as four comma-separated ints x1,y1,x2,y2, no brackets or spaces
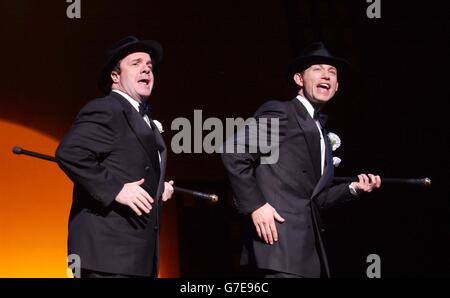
56,36,173,277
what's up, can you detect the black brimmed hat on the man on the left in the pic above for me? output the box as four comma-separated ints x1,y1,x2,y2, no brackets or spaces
98,36,163,94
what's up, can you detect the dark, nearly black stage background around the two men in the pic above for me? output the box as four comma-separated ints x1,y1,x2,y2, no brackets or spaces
0,0,450,277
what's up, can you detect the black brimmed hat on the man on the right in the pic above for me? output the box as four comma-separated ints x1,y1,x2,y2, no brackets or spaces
289,42,350,77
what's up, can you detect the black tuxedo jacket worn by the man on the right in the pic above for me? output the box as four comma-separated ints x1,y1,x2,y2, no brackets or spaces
222,98,352,277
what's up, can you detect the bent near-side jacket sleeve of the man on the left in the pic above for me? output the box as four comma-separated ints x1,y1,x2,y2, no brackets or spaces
55,100,123,207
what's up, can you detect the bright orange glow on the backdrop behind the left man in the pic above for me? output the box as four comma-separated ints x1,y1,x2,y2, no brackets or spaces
0,120,179,277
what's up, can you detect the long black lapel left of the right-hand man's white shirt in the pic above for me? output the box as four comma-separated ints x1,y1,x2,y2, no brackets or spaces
291,98,321,181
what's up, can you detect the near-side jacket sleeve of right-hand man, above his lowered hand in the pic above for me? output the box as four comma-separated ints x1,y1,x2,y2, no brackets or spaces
222,101,287,214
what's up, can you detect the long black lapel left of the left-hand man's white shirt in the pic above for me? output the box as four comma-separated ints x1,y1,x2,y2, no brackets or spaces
111,92,160,176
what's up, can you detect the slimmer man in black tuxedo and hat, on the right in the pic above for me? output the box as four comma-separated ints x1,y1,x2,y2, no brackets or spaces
222,43,381,277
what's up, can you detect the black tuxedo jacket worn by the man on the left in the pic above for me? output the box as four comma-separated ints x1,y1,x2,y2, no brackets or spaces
56,92,166,276
